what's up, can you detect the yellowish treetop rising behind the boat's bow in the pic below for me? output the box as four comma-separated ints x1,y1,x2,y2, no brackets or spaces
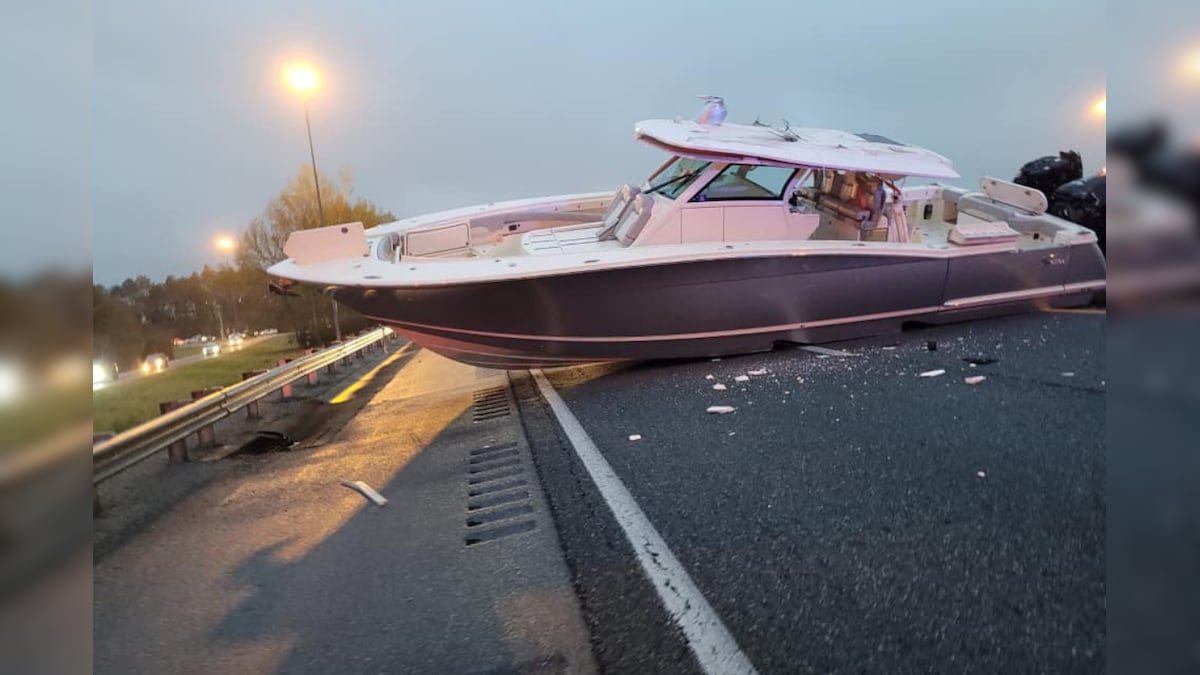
238,165,396,269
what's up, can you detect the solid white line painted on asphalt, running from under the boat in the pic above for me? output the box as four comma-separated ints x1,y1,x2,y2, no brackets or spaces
530,370,758,675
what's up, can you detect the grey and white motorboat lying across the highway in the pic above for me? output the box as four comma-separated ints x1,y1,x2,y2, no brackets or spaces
269,98,1105,369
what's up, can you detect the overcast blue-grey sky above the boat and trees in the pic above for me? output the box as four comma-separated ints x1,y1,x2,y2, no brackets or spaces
0,0,1105,283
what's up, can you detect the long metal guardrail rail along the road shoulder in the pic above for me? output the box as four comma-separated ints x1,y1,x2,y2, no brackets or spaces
91,328,391,485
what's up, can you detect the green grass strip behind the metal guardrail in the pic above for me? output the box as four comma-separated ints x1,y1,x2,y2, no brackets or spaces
91,335,304,431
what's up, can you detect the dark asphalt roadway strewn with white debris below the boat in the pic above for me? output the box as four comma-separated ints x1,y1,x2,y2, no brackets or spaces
518,313,1105,673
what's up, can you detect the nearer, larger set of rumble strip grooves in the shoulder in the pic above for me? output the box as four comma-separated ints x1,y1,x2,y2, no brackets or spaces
463,439,538,546
